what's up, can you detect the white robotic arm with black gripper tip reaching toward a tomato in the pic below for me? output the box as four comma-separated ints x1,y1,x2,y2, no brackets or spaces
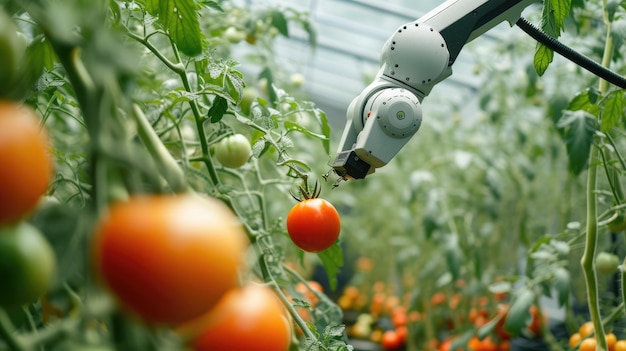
332,0,538,180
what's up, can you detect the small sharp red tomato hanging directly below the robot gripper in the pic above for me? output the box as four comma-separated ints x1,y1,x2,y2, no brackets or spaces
287,198,341,252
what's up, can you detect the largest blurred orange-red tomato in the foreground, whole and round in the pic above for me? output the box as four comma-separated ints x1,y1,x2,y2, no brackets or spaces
93,195,247,325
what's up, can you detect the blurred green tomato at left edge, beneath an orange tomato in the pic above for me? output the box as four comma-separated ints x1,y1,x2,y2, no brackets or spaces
0,222,56,308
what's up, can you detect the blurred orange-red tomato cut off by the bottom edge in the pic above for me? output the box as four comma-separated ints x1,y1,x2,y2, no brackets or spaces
182,283,291,351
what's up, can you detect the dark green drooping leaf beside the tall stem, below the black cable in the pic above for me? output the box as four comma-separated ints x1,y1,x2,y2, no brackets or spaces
557,110,598,175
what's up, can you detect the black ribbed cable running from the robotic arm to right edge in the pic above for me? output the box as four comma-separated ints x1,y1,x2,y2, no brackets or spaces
516,17,626,89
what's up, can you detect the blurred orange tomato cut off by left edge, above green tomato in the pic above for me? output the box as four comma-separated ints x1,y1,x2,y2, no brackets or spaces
0,101,52,224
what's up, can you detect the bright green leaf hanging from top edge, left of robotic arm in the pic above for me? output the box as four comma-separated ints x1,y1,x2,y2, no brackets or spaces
146,0,204,56
